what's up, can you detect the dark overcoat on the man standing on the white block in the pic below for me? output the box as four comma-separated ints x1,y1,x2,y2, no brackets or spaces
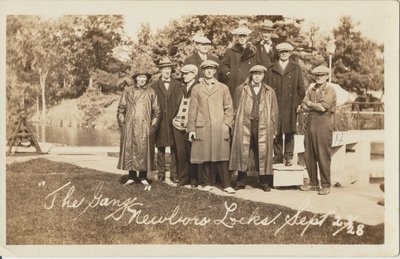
266,61,305,133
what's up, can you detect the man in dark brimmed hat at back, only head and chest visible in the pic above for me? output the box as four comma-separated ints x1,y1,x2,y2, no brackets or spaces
256,20,278,70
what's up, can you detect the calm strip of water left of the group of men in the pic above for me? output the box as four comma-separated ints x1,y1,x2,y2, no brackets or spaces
31,123,120,146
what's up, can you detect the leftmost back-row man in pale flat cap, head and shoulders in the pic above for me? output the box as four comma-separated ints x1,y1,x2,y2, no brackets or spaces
183,35,219,80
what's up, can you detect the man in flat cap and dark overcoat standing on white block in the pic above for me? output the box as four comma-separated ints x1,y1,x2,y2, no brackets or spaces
266,42,305,166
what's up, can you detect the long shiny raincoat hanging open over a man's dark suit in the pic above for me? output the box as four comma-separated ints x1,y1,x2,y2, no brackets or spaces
229,82,279,175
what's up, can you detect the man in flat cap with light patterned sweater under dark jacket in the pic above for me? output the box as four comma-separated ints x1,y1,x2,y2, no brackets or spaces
171,64,198,188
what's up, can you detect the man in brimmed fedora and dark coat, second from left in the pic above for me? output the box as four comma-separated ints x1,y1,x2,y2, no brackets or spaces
150,57,180,183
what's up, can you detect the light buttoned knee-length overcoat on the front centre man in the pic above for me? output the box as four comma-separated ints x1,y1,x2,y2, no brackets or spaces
188,80,233,164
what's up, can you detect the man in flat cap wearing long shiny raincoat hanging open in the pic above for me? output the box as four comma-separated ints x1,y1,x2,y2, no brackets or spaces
229,65,278,192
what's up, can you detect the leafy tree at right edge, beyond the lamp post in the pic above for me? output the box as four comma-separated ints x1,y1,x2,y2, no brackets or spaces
332,16,384,94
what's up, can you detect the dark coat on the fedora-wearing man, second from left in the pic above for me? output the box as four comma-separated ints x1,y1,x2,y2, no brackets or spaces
150,78,181,147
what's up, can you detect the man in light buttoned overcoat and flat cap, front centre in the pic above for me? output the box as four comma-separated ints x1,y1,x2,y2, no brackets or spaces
187,60,235,193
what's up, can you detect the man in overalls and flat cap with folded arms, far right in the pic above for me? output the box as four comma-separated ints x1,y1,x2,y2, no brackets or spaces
298,66,336,195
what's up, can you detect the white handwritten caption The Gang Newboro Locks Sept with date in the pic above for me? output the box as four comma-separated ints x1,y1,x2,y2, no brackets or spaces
44,182,364,239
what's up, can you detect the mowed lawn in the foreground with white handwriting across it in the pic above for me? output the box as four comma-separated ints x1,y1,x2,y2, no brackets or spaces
6,158,384,245
